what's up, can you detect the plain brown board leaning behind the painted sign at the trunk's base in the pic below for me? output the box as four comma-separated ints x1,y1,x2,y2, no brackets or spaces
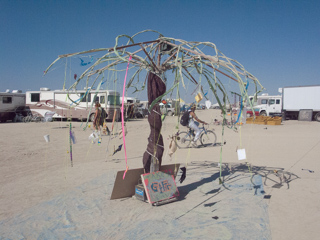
110,163,180,200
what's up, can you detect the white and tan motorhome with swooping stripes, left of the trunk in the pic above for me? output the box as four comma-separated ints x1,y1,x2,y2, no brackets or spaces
26,88,121,121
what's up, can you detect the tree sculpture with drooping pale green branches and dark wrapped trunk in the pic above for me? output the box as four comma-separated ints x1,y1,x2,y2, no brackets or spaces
45,30,263,172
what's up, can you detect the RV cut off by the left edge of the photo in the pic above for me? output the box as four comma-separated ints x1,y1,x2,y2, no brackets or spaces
0,90,26,122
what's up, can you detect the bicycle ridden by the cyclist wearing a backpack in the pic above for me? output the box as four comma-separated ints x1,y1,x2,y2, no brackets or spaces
175,124,217,148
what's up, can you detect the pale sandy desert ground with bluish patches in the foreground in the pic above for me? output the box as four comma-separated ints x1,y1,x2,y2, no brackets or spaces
0,109,320,240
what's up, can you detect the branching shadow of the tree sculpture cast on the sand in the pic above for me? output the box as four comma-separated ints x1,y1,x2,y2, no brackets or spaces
176,161,299,220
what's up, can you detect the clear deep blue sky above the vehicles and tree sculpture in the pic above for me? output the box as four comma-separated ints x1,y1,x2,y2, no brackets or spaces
0,0,320,101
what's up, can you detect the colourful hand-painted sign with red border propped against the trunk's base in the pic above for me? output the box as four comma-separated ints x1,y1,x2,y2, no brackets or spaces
141,169,179,204
